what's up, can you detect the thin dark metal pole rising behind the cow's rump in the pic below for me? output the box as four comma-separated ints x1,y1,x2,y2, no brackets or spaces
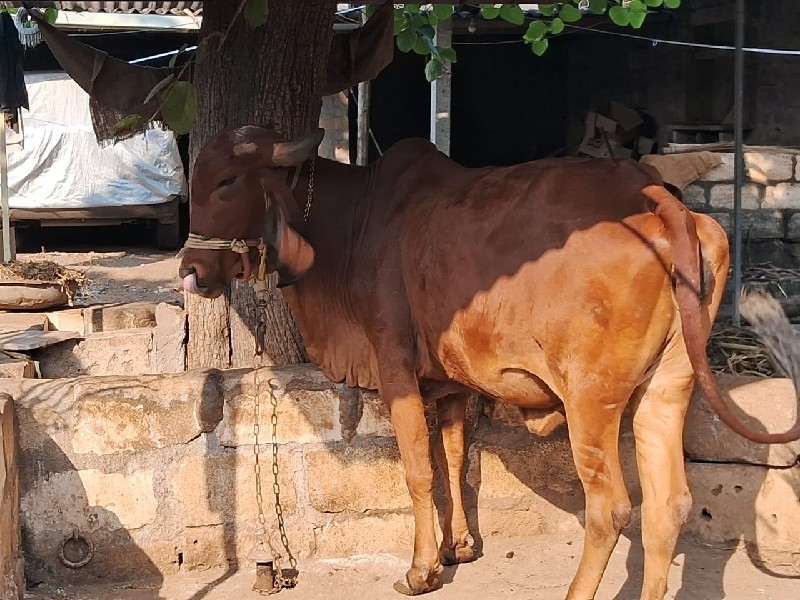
733,0,744,326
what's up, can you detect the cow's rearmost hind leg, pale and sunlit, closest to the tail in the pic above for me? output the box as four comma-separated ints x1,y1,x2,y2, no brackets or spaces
633,356,692,600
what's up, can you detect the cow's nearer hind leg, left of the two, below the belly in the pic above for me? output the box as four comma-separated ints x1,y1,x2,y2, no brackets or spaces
565,391,631,600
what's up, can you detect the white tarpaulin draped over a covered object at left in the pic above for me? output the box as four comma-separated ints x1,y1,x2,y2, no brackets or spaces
8,72,187,209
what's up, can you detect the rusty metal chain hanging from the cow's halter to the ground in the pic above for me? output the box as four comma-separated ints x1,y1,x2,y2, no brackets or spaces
253,294,298,594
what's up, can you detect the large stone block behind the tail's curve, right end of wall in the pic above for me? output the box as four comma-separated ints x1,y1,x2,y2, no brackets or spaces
683,375,800,467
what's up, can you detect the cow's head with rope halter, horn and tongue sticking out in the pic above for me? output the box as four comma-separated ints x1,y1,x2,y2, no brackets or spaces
180,125,324,298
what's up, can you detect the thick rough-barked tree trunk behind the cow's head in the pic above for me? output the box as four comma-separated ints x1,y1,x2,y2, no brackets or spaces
186,0,336,368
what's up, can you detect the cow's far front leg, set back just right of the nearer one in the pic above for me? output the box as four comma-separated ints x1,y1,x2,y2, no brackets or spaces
435,392,475,565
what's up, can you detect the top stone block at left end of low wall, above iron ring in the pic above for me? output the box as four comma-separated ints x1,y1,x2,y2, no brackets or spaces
0,369,223,454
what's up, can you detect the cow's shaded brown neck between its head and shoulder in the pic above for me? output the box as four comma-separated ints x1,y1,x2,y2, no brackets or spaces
284,158,374,387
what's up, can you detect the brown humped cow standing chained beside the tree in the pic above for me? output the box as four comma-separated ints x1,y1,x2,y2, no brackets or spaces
181,126,800,599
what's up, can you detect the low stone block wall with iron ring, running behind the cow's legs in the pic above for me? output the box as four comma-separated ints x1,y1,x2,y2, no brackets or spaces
0,365,800,582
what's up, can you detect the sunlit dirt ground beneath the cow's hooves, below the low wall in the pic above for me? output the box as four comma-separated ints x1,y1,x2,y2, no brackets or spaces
25,535,800,600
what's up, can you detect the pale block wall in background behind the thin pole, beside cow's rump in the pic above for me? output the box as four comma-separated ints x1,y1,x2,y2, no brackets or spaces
683,151,800,242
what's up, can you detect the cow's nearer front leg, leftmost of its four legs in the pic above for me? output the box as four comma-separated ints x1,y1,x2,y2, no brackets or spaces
380,372,442,595
